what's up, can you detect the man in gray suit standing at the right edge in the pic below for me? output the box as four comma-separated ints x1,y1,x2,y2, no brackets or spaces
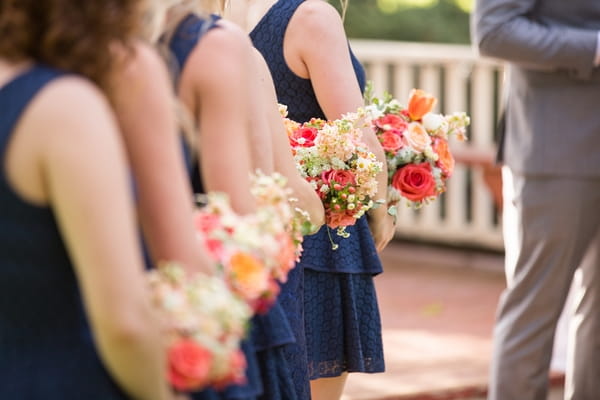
472,0,600,400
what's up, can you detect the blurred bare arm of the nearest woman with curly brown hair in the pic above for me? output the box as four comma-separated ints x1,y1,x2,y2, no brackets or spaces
30,78,168,400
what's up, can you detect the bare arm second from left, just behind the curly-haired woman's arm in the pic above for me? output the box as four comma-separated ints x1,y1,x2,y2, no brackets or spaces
112,44,213,274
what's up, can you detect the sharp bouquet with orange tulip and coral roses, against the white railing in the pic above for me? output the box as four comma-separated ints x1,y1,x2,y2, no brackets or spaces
365,89,470,211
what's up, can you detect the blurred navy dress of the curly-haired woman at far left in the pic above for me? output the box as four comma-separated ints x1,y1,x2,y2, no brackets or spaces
0,66,129,400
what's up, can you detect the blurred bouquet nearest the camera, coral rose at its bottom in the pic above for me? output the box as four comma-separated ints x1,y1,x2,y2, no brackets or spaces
148,264,251,391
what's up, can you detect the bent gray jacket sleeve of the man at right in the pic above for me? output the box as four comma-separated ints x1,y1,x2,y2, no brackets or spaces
471,0,598,79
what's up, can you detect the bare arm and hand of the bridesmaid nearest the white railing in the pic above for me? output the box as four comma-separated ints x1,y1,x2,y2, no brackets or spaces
284,0,394,250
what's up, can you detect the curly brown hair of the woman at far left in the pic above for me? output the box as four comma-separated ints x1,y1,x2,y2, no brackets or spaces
0,0,145,88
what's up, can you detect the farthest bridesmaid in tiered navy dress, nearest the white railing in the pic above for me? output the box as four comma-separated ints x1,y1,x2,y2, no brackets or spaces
232,0,394,400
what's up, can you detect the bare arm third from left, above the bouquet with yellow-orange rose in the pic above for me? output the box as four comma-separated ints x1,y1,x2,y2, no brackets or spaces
180,22,256,214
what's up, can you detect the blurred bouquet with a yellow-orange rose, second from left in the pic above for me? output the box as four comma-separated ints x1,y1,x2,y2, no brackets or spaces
195,172,310,314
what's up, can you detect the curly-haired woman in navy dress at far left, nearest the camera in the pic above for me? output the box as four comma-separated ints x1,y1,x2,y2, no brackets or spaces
0,0,172,400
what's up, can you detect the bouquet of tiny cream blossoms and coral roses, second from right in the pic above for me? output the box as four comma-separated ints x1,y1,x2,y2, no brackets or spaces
280,106,382,239
